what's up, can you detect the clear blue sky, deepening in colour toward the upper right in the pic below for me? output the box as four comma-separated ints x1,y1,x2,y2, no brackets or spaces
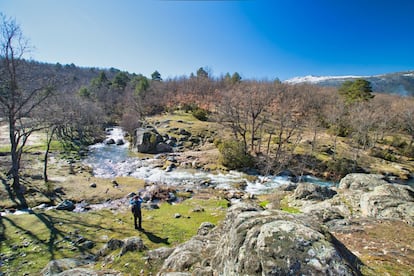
0,0,414,80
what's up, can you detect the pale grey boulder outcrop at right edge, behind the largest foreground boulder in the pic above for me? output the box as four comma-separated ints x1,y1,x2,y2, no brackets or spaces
289,173,414,225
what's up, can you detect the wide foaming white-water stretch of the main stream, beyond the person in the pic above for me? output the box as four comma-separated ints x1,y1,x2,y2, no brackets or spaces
84,127,329,194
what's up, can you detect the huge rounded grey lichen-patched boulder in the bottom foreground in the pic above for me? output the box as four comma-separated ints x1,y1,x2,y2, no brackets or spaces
157,203,360,275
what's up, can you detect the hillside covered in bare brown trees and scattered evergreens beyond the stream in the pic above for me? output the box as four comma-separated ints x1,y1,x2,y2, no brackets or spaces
4,59,414,184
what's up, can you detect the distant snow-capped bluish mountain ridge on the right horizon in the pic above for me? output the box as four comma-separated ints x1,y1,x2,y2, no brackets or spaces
284,71,414,96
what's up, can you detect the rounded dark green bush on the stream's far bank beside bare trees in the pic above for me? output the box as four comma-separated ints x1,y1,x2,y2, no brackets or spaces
218,140,253,170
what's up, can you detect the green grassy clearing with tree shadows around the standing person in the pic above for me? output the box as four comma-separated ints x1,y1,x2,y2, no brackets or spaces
0,199,227,275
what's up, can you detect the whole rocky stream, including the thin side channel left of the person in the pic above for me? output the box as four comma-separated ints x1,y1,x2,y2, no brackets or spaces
0,127,334,216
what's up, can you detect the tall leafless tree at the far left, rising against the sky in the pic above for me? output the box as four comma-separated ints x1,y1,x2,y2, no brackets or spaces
0,14,52,199
